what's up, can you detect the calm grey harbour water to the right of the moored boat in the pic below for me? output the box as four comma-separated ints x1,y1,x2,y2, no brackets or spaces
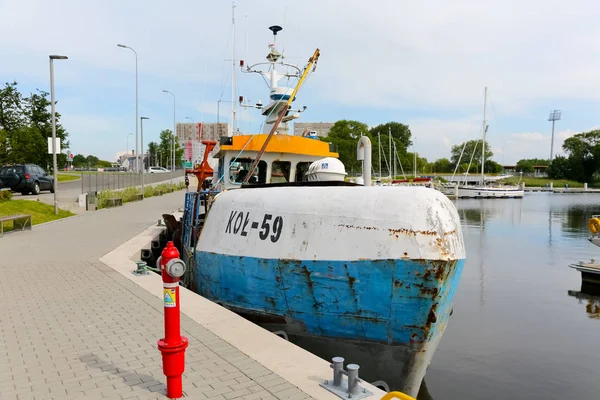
425,193,600,400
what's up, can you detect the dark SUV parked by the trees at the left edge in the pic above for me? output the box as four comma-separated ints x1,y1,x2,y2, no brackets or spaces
0,164,54,195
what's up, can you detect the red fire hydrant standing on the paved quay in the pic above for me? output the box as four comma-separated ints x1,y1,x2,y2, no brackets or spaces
158,242,188,399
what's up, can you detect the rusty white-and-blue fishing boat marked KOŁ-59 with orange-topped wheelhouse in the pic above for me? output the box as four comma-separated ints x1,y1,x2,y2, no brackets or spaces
180,27,465,396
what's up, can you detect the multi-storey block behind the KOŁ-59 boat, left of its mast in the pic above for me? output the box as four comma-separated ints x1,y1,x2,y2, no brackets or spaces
175,122,228,168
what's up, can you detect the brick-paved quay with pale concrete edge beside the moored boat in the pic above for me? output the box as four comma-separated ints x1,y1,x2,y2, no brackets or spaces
0,192,384,400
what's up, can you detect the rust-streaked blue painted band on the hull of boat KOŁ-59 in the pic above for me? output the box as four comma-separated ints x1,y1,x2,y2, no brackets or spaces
195,255,464,347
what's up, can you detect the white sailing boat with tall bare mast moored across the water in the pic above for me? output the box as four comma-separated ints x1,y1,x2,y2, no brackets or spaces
458,87,525,198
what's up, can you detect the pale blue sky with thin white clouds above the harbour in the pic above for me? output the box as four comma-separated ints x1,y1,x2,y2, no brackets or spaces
0,0,600,165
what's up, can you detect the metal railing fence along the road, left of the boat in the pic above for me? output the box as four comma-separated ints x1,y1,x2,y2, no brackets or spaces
81,171,184,193
